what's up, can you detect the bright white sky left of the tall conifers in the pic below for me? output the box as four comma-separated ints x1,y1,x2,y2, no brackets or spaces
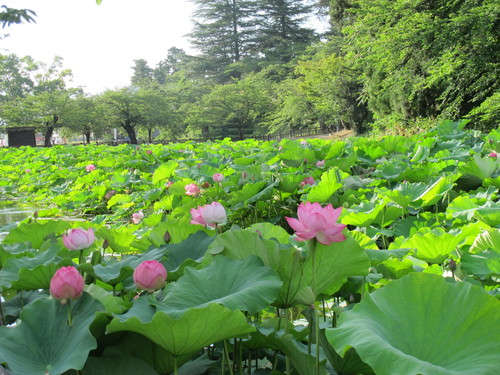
0,0,195,94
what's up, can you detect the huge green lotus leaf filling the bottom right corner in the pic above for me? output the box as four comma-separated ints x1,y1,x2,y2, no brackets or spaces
326,273,500,375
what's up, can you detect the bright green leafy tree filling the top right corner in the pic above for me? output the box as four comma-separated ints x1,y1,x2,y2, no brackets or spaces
346,0,500,129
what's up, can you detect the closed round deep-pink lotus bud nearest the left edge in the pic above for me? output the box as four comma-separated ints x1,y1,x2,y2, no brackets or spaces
50,266,85,300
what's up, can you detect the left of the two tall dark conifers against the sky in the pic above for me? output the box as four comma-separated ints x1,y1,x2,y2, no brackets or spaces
189,0,255,82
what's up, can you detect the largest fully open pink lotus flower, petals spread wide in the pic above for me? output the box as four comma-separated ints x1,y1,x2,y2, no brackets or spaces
286,202,346,245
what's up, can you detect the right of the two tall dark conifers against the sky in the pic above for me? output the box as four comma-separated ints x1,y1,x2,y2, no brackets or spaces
256,0,315,63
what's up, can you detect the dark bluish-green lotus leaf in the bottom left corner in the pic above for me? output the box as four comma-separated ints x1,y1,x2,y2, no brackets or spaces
0,293,102,375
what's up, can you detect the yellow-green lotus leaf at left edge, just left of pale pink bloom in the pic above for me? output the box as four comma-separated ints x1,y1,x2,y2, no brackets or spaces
3,220,71,249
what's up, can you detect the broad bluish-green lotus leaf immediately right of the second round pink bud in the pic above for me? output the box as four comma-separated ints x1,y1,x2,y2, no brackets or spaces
157,256,283,317
